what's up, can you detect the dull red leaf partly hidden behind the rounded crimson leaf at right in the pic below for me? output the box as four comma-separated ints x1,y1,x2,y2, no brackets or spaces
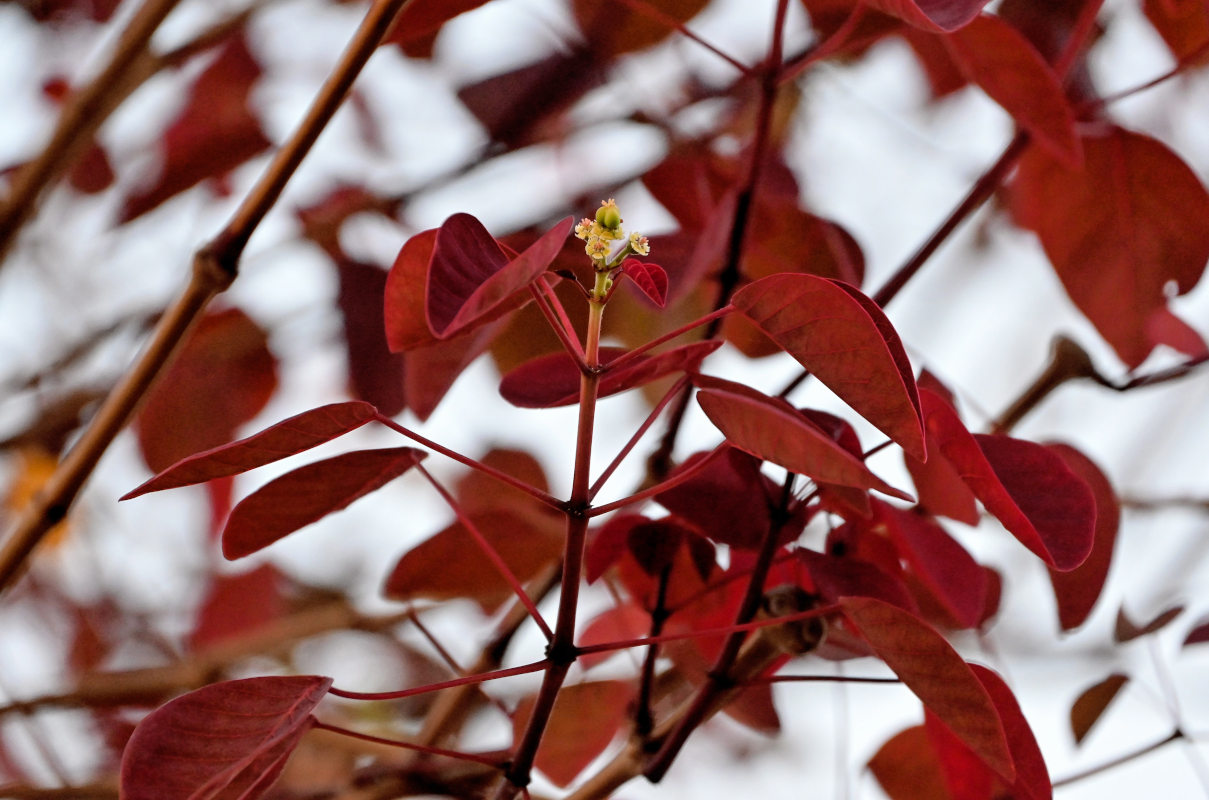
1049,445,1121,631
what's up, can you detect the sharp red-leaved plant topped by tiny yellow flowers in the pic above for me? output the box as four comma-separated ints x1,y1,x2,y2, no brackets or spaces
122,199,1097,799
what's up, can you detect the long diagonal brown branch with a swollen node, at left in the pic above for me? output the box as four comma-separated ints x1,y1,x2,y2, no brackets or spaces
0,0,410,591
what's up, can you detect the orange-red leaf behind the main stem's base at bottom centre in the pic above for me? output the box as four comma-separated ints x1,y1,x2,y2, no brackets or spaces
513,680,634,787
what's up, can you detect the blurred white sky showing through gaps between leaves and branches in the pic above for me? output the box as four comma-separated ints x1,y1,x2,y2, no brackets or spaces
0,0,1209,800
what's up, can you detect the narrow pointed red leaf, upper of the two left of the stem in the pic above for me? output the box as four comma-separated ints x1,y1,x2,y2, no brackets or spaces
121,400,377,500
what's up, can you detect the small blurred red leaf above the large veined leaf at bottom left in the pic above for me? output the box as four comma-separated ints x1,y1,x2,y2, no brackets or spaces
189,564,285,651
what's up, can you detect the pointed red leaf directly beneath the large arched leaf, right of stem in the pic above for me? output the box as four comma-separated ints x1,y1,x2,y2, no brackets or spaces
696,378,910,500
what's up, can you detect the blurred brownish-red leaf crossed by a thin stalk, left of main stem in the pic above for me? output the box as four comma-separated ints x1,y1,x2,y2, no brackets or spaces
384,510,562,610
